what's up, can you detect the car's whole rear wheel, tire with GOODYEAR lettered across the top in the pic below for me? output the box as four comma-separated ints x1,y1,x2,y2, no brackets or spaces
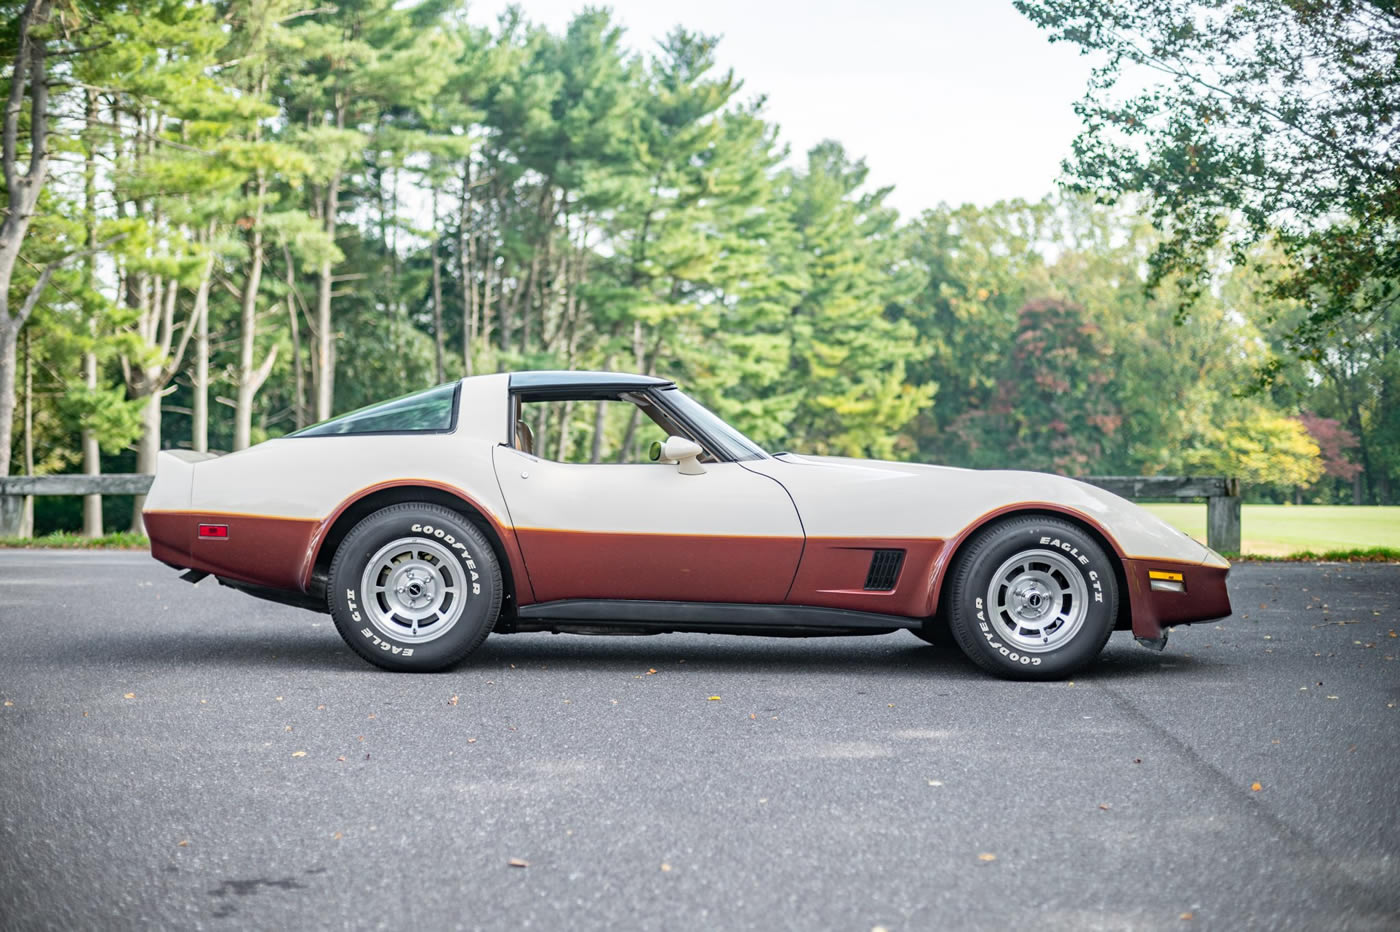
326,502,503,672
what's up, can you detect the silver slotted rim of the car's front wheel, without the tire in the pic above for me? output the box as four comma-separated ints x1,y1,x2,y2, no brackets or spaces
987,550,1089,654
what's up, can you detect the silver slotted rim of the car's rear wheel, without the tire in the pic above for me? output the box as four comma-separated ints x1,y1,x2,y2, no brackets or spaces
360,537,466,644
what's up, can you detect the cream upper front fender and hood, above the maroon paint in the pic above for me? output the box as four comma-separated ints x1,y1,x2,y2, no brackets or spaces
745,453,1224,564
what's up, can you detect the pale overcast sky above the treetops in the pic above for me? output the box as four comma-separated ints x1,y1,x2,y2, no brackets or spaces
472,0,1089,216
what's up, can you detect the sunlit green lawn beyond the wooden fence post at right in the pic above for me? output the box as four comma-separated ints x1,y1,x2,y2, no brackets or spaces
1144,504,1400,557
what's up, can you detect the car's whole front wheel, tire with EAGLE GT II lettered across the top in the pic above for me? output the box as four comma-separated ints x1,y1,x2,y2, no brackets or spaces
945,515,1119,680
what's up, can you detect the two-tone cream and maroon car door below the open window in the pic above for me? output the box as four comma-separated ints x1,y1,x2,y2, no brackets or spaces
494,445,802,603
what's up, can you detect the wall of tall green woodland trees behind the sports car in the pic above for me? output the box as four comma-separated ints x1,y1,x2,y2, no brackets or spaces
11,0,1400,523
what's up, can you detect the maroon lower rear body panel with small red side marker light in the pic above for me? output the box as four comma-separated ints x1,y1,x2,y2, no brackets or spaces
143,511,321,591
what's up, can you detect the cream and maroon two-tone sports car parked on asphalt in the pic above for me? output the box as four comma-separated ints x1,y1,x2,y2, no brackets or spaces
146,372,1231,679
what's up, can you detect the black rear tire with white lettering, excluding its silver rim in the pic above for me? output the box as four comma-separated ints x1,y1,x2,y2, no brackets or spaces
326,504,501,670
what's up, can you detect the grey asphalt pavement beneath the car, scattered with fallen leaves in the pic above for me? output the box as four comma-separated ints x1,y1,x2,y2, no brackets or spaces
0,551,1400,932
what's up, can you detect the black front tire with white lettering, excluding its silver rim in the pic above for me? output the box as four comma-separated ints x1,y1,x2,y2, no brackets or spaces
949,518,1117,679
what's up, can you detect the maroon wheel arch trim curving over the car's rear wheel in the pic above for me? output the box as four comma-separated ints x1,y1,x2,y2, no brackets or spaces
301,480,533,612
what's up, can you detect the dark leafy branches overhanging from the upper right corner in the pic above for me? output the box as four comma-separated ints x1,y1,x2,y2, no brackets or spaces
1015,0,1400,382
